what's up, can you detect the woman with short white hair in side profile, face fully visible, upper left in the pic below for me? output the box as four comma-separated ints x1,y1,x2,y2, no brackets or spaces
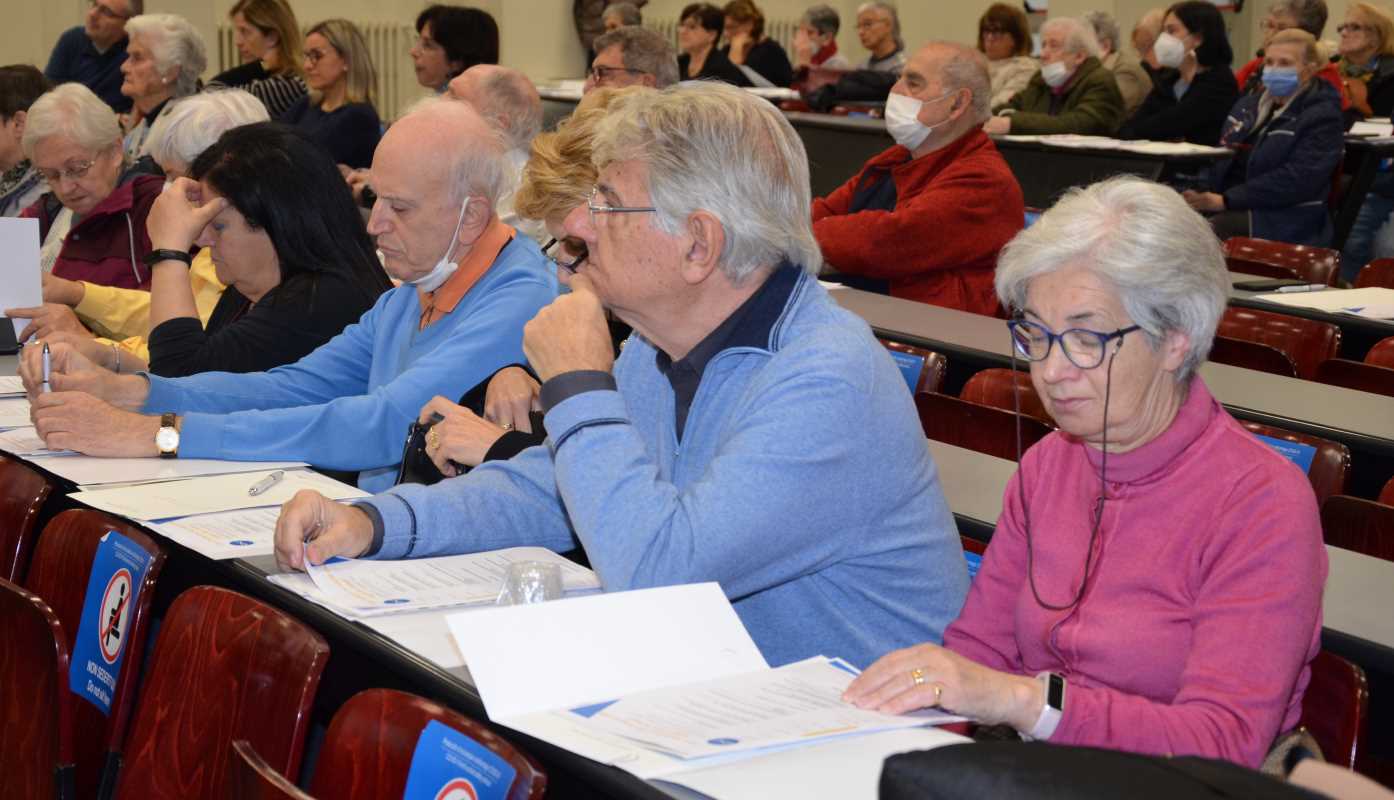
121,14,208,159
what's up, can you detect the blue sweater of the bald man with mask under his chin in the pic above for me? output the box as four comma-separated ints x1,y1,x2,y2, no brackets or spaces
144,236,556,492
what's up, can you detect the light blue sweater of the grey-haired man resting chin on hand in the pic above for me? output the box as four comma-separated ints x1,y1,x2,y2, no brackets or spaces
367,273,967,666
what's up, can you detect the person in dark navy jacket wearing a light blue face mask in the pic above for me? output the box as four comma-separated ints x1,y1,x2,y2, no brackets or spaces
1184,29,1345,247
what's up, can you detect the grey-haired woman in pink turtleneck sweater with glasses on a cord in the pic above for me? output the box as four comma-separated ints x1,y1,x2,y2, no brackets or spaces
846,178,1326,767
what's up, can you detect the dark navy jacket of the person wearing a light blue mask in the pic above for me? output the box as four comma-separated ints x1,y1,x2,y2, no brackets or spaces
1214,78,1345,247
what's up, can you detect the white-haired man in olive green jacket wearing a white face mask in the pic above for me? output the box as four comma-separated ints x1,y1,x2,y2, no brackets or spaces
983,17,1124,137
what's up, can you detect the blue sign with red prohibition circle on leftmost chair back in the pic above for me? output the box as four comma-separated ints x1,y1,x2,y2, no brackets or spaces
68,531,151,714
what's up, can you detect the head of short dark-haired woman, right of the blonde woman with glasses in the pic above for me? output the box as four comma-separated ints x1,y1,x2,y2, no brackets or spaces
411,6,499,92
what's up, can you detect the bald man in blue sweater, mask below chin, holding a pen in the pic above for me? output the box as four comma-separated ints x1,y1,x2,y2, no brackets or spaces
22,99,556,492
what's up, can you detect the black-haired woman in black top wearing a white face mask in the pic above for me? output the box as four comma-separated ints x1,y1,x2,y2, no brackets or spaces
1118,0,1239,145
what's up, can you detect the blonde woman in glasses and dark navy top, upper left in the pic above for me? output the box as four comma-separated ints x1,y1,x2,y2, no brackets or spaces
280,20,382,169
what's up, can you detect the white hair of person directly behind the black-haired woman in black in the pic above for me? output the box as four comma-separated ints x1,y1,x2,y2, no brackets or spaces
144,89,270,169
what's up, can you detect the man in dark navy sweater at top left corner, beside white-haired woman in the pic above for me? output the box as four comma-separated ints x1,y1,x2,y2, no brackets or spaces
43,0,145,114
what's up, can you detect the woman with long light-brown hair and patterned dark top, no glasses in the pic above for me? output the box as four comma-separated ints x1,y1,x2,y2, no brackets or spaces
208,0,308,118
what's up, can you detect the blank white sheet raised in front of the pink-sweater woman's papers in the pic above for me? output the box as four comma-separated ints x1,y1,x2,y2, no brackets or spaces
446,583,768,721
